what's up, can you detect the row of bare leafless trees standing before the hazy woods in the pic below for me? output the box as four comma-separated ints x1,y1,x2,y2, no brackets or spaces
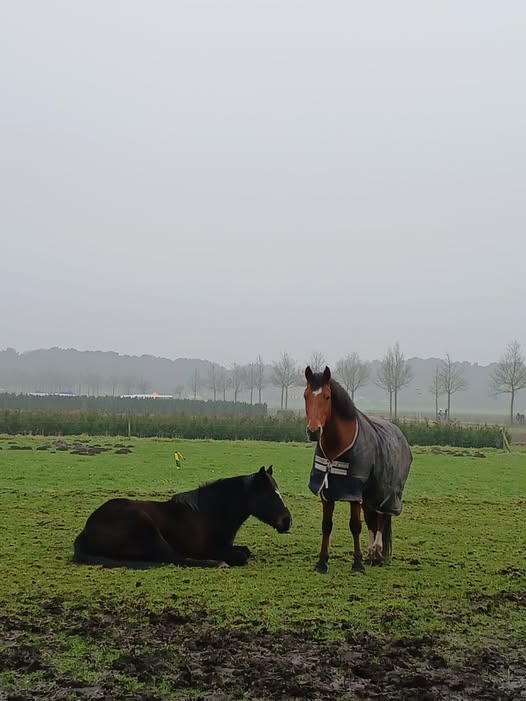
213,341,526,423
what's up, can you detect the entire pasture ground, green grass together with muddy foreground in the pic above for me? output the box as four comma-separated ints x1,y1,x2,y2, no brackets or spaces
0,438,526,700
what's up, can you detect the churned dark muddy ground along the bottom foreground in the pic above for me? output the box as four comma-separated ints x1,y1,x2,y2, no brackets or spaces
0,598,526,701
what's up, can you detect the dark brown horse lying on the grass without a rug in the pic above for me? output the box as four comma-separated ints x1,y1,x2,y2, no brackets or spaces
73,465,292,568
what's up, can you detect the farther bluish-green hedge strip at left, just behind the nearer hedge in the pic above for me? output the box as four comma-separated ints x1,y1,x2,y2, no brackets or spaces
0,392,267,416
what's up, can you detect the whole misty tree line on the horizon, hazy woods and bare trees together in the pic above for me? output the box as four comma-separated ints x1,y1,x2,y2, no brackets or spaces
0,341,526,423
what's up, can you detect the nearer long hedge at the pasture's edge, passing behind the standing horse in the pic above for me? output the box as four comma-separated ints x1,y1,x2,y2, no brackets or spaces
0,409,510,448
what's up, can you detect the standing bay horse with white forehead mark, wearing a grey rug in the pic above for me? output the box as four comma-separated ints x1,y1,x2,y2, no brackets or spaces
304,366,413,573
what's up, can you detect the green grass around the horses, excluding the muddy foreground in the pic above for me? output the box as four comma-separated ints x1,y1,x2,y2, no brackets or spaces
0,438,526,693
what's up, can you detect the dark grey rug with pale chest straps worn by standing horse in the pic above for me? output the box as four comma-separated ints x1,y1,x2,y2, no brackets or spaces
309,410,413,516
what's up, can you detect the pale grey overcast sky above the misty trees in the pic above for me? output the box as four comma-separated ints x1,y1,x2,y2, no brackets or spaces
0,0,526,363
